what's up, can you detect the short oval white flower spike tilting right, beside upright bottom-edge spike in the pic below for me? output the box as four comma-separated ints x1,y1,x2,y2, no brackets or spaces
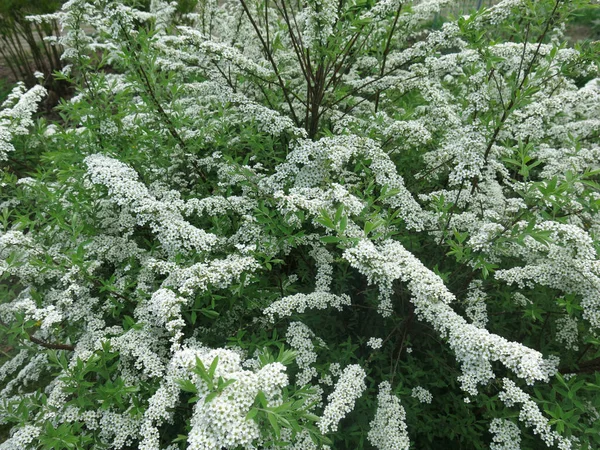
318,364,367,434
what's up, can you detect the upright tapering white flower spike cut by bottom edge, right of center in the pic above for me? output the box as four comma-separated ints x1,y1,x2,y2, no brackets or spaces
367,381,410,450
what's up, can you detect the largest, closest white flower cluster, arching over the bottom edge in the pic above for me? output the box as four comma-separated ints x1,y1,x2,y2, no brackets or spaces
140,347,288,450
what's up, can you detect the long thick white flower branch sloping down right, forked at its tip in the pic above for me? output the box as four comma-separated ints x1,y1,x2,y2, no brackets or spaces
344,240,556,395
